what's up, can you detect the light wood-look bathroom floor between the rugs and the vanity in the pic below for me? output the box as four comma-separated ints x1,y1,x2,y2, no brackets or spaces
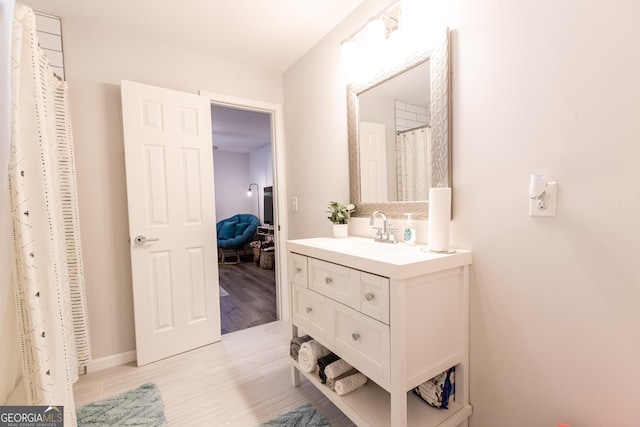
74,321,354,427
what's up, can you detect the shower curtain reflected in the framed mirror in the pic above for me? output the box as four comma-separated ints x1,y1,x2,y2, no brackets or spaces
397,127,431,201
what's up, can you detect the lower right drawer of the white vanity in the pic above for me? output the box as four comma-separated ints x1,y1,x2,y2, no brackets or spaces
333,304,390,384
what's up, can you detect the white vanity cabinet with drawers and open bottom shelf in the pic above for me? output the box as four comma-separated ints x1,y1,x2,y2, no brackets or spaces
287,237,472,427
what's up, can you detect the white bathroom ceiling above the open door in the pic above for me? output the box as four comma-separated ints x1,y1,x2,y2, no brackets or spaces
19,0,364,74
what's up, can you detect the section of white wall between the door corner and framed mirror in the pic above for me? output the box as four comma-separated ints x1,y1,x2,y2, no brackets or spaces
284,0,388,238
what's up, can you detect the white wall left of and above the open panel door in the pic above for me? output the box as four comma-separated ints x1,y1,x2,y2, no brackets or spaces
27,15,282,358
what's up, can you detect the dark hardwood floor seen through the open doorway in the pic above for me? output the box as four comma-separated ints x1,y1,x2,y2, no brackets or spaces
218,261,277,334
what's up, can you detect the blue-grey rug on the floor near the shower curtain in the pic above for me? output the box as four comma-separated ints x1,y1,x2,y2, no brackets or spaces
76,383,167,427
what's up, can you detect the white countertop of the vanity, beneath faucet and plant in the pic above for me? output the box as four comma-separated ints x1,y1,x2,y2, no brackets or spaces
287,236,471,280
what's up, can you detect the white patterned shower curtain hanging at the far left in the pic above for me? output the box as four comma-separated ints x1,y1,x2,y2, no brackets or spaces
9,4,91,426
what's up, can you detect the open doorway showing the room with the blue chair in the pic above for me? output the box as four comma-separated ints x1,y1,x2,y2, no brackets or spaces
211,103,278,334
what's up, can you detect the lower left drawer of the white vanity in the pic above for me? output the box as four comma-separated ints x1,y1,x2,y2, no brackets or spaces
292,286,334,344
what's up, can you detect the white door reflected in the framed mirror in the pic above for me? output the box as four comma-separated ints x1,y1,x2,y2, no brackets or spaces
358,122,389,202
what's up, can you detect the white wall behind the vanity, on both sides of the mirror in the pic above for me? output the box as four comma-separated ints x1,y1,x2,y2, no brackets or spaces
284,0,640,427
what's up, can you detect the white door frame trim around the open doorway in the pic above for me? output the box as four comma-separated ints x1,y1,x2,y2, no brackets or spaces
200,90,289,321
